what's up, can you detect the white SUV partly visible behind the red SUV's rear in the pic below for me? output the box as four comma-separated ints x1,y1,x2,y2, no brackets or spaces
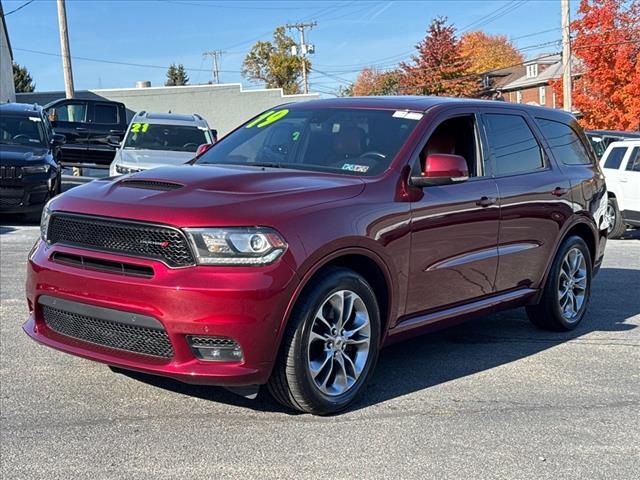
600,138,640,238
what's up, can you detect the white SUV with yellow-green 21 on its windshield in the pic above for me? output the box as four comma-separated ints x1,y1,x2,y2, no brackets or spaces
109,112,217,175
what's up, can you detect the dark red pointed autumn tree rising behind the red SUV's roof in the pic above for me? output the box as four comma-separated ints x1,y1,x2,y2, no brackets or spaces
399,17,479,97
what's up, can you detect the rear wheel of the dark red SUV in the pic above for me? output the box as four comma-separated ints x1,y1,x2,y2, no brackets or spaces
526,236,592,331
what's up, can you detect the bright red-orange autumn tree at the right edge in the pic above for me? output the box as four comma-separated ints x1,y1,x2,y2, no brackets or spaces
552,0,640,130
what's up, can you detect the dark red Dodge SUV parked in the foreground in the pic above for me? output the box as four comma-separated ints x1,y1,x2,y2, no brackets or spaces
24,97,608,414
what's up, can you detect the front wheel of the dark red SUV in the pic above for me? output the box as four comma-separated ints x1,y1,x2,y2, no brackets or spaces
268,268,380,415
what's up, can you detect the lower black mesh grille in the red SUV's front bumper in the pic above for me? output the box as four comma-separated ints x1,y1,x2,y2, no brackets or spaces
41,305,173,358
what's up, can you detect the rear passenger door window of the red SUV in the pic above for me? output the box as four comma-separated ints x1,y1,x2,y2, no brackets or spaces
485,114,544,175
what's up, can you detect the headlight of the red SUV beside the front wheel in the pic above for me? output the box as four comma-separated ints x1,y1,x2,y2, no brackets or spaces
185,228,287,265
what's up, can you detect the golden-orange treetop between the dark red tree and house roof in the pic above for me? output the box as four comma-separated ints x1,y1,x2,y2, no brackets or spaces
460,31,524,73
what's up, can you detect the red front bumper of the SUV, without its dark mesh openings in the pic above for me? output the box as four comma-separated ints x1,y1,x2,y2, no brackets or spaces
23,242,297,386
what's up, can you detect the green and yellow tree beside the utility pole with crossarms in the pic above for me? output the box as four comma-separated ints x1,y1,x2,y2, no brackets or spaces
242,27,311,95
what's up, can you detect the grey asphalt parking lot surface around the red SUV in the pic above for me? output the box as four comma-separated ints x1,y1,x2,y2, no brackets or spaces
0,225,640,479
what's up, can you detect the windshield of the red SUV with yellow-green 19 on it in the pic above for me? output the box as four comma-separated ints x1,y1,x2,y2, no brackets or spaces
195,108,422,176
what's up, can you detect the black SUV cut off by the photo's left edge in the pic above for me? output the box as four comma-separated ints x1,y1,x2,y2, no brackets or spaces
0,103,64,220
